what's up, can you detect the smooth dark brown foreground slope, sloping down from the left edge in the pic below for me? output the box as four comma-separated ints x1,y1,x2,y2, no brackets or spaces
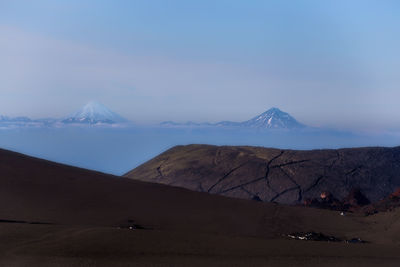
0,150,400,266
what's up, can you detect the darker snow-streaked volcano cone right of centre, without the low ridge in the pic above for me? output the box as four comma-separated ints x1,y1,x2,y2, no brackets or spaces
241,108,305,129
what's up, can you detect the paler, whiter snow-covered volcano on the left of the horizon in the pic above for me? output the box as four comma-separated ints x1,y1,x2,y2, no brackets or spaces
63,101,127,124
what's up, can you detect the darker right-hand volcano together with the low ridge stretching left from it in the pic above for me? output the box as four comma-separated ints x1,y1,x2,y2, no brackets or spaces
161,108,306,129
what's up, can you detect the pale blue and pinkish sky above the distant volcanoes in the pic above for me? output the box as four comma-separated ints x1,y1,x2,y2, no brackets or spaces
0,0,400,131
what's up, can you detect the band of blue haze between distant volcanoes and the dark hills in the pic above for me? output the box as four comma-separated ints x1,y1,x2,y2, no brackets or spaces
0,127,400,175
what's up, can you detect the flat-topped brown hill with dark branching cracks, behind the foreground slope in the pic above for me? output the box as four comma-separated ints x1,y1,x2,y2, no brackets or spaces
125,145,400,204
